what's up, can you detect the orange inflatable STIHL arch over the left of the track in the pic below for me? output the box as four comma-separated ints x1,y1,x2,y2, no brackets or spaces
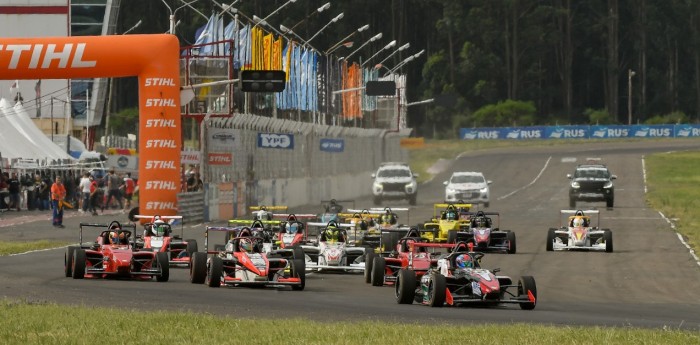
0,35,182,215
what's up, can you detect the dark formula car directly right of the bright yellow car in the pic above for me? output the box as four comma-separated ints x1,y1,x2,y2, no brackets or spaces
456,211,516,254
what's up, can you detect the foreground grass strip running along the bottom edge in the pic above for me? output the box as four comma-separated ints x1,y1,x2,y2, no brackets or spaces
0,300,700,345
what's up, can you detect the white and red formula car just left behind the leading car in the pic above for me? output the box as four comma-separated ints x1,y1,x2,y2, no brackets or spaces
190,227,306,290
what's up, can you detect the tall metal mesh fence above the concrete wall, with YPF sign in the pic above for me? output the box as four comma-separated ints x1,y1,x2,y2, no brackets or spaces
201,114,410,183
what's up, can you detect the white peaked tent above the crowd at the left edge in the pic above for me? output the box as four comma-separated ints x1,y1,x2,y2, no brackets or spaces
0,99,72,162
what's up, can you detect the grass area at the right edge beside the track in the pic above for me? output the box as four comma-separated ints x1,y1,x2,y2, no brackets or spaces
645,152,700,248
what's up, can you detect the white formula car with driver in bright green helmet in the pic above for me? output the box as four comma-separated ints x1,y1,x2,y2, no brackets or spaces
302,221,365,272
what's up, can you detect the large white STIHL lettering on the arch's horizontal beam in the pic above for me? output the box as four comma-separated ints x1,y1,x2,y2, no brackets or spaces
0,43,97,69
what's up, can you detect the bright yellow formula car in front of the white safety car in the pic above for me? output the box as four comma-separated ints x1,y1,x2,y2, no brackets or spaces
422,204,472,243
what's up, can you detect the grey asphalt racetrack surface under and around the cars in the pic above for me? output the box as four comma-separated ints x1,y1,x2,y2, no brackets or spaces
0,140,700,330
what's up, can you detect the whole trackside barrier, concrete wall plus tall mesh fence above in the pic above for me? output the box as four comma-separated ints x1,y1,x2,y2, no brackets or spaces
192,114,410,220
